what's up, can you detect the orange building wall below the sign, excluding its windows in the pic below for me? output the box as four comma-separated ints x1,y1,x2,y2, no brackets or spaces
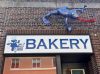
3,57,56,74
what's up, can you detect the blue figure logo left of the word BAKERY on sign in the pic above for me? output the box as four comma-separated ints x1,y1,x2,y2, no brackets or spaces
7,39,25,52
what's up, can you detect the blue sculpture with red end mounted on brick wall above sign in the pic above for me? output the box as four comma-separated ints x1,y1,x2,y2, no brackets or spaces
42,5,96,32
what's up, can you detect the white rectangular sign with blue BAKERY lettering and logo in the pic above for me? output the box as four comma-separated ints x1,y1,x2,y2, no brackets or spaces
4,35,92,54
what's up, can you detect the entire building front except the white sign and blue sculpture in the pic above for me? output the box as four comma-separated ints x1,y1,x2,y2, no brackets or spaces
0,0,100,74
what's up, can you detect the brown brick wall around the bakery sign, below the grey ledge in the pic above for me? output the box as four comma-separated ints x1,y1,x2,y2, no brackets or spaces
0,7,100,74
